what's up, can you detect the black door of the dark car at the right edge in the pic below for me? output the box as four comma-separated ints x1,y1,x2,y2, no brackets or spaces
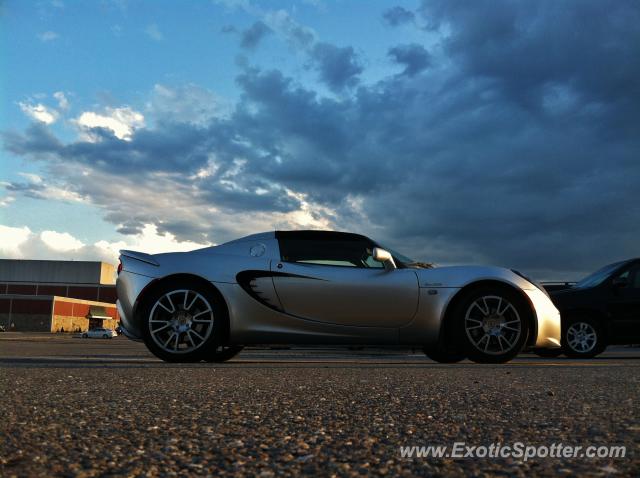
608,263,640,342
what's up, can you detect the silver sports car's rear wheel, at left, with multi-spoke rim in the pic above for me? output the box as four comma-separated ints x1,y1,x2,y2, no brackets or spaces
140,280,228,363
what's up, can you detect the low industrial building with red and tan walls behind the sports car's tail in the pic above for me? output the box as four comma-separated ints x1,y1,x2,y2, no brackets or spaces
0,259,119,332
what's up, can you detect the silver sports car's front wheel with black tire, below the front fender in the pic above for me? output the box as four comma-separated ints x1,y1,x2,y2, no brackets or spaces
453,285,532,363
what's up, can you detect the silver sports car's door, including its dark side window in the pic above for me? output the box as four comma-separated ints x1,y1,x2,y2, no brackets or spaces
272,236,419,327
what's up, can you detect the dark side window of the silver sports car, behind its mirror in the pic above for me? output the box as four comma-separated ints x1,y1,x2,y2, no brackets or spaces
280,239,384,268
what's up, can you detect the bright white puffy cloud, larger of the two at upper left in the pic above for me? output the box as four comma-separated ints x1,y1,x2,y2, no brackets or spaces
75,106,145,142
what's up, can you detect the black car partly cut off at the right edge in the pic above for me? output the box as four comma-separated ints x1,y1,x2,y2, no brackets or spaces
550,258,640,358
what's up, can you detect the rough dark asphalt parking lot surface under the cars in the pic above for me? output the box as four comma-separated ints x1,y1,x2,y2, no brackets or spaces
0,333,640,477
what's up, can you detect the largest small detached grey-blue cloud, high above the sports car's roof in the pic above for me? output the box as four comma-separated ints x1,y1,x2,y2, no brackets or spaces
311,42,363,92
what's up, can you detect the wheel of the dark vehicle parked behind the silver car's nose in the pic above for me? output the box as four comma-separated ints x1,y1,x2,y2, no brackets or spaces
562,317,607,358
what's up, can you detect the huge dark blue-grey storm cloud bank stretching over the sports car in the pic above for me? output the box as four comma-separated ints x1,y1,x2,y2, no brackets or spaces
5,1,640,279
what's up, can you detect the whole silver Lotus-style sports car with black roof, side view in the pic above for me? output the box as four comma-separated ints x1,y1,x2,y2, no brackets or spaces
117,231,560,363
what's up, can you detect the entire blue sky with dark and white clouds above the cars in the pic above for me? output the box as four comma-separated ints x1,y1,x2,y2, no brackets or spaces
0,0,640,279
